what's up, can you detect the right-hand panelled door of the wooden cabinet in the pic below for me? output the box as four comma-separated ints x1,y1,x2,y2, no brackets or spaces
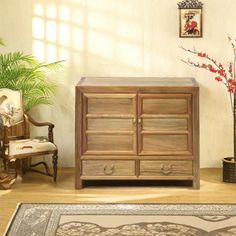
138,94,192,155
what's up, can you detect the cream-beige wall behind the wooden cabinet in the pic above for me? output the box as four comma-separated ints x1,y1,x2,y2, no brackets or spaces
0,0,236,167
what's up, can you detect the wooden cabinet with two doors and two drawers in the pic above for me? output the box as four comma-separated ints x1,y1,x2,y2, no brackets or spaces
75,77,199,189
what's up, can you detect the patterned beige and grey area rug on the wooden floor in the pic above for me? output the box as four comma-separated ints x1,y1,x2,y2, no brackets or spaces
5,204,236,236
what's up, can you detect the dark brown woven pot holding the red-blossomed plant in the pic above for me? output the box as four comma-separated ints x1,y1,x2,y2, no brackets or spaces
223,157,236,183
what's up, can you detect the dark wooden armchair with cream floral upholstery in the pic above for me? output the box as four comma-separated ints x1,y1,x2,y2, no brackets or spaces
0,89,58,188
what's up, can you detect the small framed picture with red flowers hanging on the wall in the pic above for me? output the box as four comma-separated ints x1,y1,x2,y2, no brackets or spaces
178,0,203,38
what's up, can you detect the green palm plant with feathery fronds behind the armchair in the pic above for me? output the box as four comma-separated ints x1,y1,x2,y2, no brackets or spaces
0,39,61,112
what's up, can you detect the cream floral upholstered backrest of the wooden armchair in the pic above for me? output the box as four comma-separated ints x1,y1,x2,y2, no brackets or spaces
0,88,24,127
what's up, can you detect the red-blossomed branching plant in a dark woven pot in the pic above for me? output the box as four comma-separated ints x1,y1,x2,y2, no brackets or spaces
181,36,236,183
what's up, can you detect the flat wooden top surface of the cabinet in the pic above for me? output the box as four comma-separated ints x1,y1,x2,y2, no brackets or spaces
77,77,198,87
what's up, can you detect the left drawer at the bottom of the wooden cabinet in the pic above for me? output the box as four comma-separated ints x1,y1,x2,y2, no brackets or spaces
82,160,135,177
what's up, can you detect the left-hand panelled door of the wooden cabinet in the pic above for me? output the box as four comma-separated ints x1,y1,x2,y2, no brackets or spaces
82,93,137,155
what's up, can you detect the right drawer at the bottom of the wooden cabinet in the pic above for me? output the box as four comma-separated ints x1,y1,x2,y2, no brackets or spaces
140,160,193,176
